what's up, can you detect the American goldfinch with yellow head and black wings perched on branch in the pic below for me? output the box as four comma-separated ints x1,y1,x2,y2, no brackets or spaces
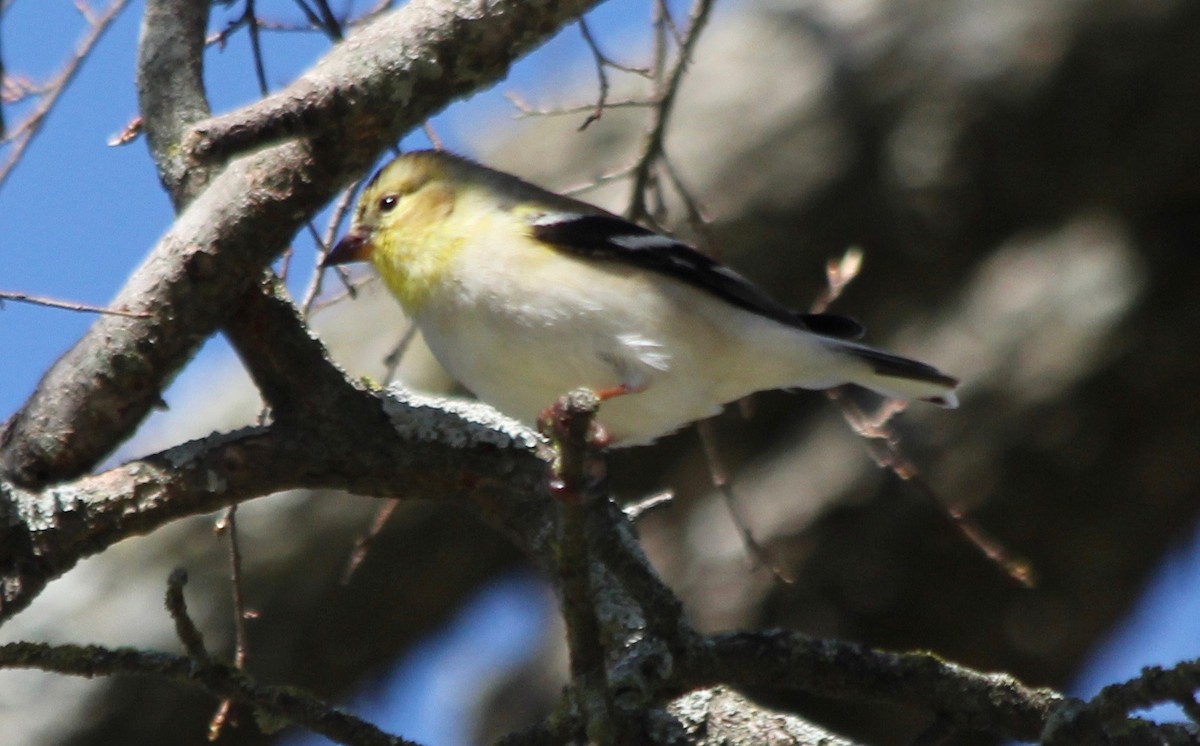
324,151,958,445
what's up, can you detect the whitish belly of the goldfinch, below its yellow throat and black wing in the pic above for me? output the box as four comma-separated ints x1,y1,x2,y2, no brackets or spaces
416,256,791,445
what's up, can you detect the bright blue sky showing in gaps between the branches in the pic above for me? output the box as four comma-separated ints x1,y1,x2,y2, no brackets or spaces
0,0,1200,742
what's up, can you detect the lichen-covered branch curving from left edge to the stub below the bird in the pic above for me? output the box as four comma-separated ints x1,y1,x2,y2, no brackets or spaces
0,383,551,621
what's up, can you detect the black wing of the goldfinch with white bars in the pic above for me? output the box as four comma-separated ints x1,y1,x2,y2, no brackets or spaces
533,212,863,339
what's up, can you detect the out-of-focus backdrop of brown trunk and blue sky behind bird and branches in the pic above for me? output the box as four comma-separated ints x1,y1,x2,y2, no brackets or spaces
0,0,1200,746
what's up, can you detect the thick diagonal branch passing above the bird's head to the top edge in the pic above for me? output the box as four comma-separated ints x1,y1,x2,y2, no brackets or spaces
0,0,595,486
